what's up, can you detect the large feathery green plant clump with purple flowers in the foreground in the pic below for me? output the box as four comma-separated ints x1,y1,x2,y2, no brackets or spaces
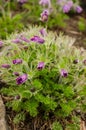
0,26,86,128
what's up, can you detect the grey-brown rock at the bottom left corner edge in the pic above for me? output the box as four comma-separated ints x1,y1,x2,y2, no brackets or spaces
0,96,7,130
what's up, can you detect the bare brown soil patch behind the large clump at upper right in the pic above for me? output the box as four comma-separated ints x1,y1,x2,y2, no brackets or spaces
53,11,86,49
